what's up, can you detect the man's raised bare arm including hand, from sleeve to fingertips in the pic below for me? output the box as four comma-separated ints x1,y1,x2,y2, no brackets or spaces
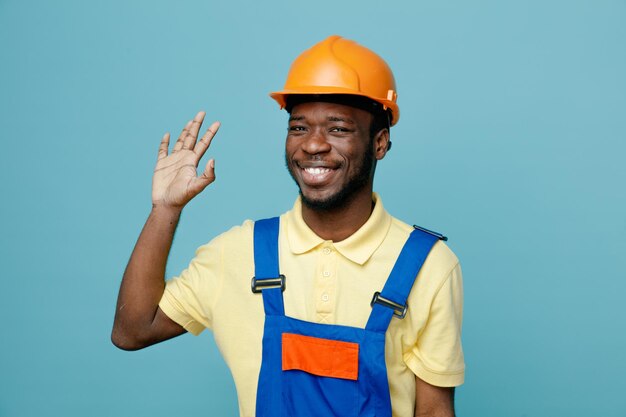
111,112,220,350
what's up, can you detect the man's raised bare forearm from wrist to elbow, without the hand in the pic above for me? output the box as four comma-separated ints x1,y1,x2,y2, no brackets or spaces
111,206,181,349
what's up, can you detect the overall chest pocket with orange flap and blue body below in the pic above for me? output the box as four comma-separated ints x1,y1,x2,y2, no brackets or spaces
282,333,359,417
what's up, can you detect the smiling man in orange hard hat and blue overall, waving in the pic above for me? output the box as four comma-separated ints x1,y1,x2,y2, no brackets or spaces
112,36,464,417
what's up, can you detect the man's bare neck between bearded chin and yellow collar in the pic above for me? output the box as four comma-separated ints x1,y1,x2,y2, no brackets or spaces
302,190,374,242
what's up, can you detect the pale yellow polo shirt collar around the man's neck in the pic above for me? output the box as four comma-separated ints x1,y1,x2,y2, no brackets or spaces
285,193,391,265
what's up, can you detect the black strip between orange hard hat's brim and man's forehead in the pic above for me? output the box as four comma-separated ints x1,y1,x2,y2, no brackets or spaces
285,94,392,149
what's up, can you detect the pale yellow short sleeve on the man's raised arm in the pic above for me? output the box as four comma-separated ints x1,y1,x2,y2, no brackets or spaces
159,237,223,335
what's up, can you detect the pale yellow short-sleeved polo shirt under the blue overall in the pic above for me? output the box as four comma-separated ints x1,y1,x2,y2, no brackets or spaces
159,194,464,417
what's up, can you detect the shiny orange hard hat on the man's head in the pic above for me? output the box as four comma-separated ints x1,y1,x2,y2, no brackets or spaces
270,35,400,126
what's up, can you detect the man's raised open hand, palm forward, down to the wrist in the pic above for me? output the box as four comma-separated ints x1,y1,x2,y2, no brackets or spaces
152,111,220,208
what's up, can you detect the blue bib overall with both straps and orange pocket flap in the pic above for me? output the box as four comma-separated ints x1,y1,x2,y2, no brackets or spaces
252,217,445,417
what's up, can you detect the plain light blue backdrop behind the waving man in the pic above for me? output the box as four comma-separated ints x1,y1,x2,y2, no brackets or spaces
0,0,626,417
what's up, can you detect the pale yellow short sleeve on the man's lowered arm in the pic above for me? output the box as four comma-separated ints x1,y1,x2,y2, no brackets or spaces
404,263,465,387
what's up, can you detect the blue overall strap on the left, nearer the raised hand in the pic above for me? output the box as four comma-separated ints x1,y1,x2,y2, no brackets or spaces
252,217,285,316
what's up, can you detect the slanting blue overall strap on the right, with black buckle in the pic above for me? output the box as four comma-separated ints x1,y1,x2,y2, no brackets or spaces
365,228,441,333
